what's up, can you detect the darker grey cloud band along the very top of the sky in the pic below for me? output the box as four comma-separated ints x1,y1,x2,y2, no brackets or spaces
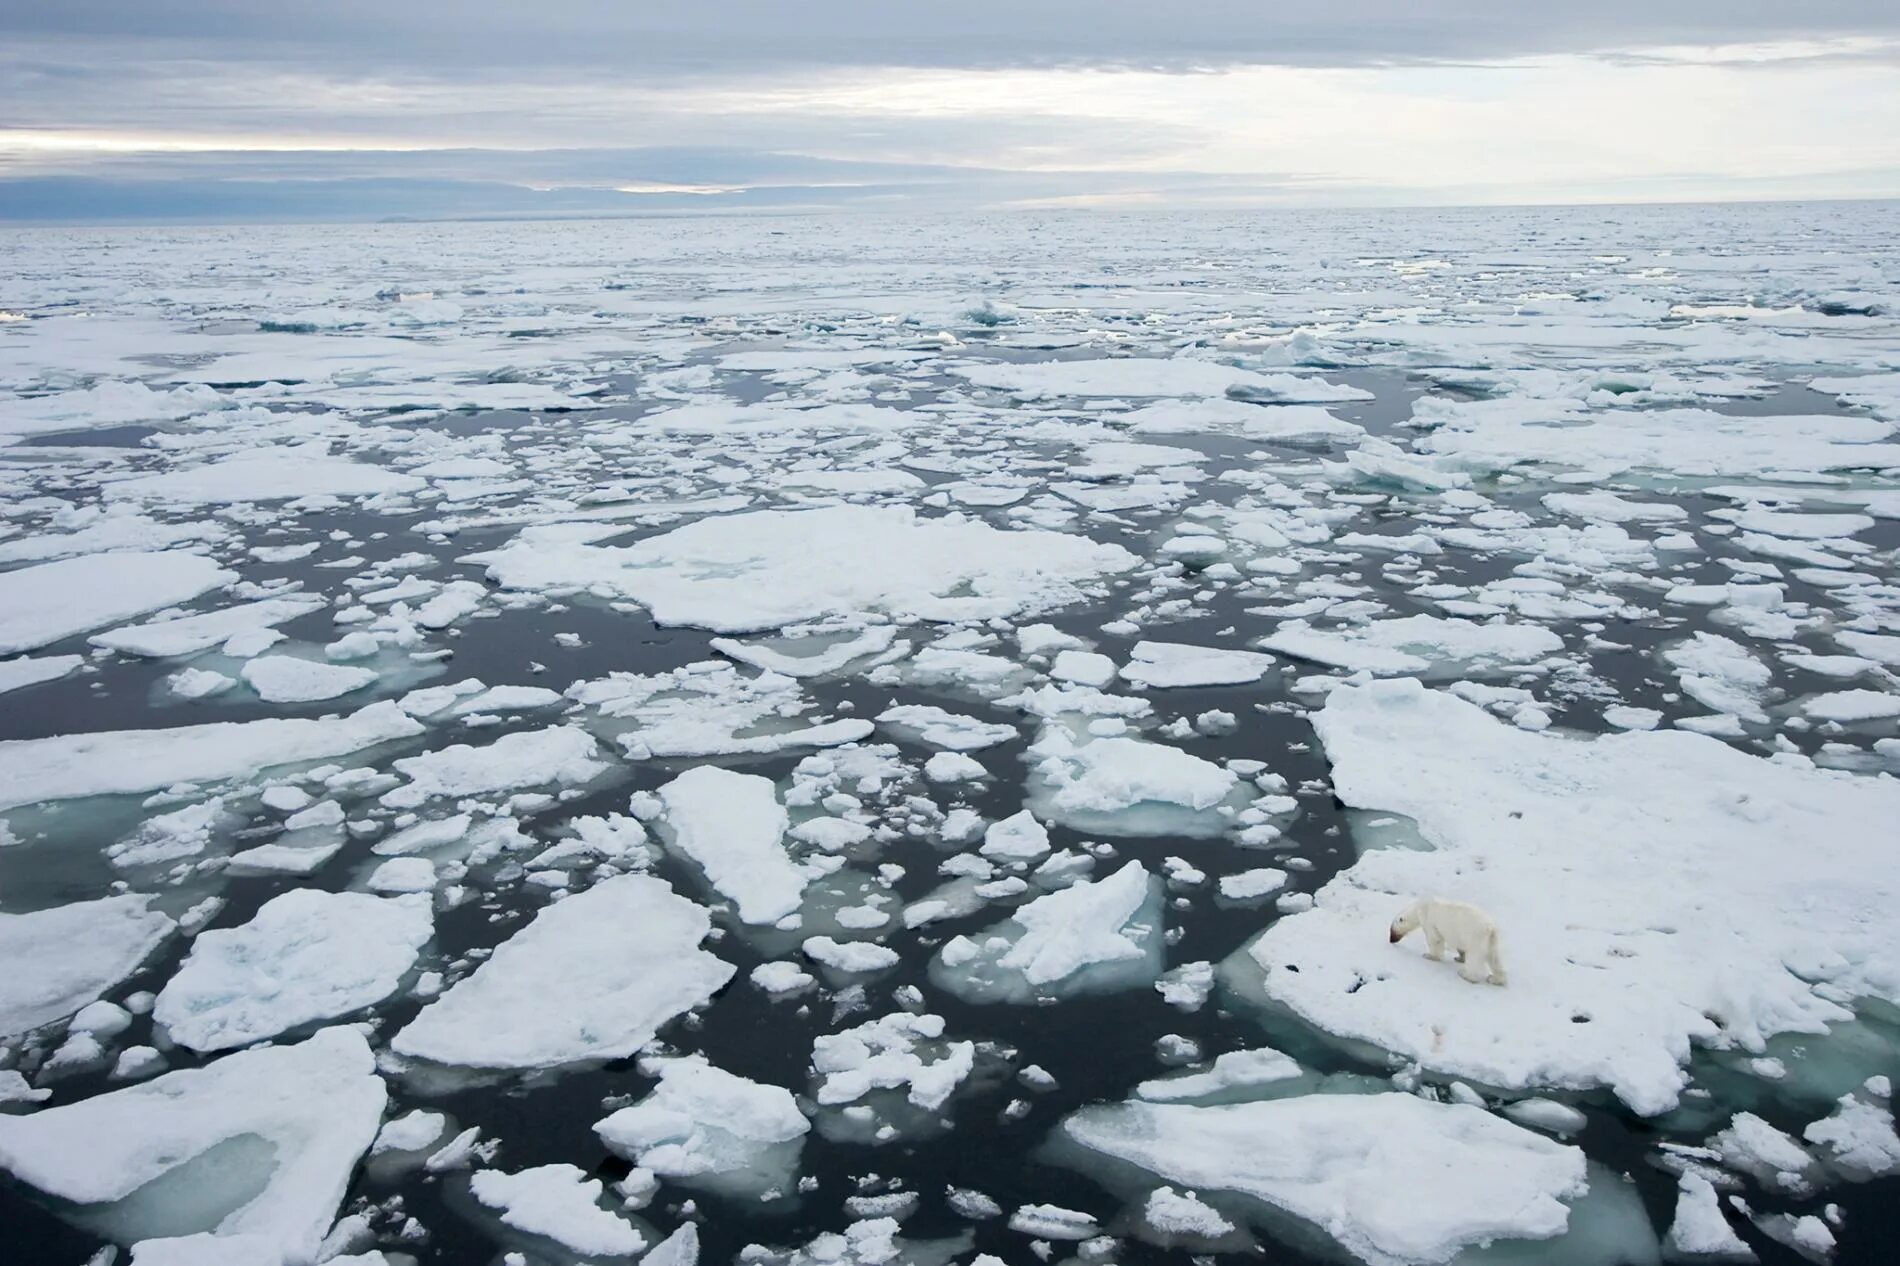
14,0,1900,74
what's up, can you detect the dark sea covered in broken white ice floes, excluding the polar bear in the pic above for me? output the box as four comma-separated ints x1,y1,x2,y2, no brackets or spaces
0,203,1900,1266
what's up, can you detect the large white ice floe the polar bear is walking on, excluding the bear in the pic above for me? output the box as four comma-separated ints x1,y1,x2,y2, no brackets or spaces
1248,681,1900,1114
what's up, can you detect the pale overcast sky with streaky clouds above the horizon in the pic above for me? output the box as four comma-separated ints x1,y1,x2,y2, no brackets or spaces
0,0,1900,222
